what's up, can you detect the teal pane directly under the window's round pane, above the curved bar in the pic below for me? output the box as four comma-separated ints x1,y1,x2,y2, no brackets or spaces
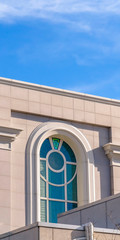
48,169,64,184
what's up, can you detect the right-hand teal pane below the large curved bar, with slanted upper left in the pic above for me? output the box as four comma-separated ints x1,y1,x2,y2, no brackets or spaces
67,177,77,201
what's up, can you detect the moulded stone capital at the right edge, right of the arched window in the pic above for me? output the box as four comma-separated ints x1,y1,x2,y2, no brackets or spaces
104,143,120,166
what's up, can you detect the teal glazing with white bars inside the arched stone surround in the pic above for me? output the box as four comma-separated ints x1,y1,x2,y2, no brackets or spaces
40,137,77,222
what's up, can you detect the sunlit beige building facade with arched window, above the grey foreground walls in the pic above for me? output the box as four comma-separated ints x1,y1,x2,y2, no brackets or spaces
0,78,120,234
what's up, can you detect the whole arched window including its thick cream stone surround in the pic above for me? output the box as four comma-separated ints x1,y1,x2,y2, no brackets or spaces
26,121,95,225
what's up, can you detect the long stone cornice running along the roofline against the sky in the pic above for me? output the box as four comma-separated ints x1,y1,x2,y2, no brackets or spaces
0,77,120,106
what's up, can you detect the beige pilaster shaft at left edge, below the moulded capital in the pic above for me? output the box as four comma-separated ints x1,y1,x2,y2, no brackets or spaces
0,149,11,233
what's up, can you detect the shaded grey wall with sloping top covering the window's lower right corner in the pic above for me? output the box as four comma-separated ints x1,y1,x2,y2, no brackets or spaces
58,194,120,230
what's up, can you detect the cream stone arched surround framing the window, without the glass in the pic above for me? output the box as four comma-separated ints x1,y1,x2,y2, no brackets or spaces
26,121,95,225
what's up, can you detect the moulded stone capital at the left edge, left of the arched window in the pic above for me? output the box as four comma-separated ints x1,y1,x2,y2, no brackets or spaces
0,126,22,150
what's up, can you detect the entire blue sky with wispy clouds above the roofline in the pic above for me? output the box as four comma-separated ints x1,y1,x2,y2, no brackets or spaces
0,0,120,99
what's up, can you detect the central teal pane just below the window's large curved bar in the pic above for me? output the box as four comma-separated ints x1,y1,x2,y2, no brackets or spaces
49,184,65,200
